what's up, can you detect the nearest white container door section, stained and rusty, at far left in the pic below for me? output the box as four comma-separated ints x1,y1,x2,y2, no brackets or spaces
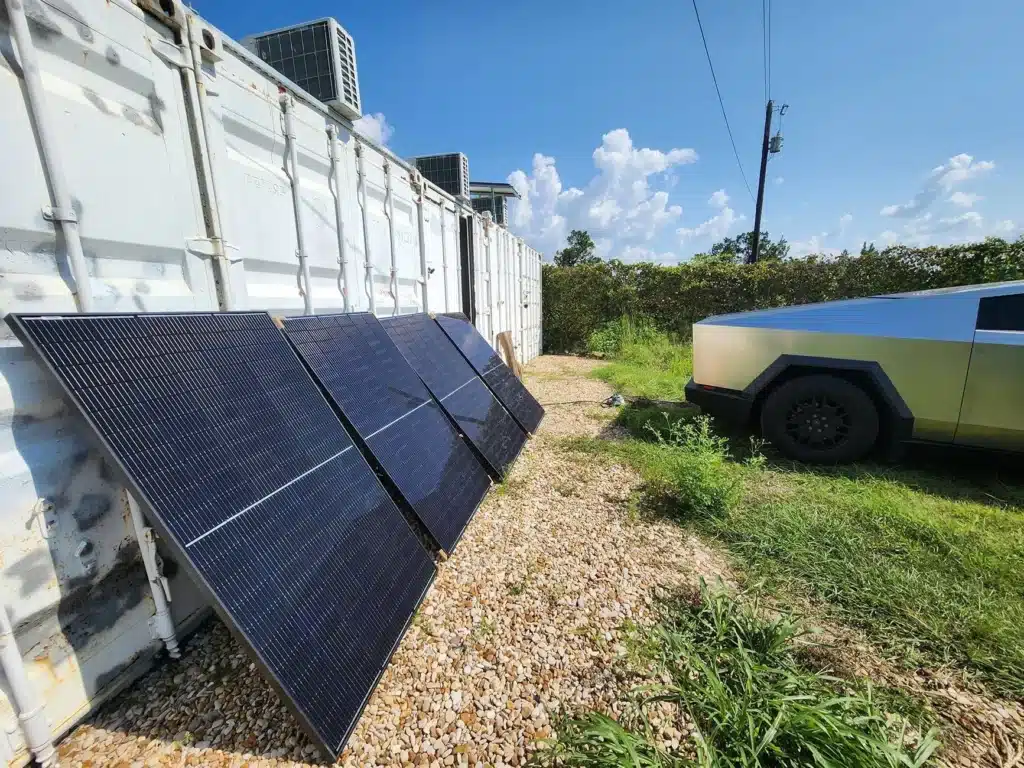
0,0,217,749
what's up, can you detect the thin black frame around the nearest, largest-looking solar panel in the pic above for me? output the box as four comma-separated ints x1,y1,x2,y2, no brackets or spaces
5,311,437,761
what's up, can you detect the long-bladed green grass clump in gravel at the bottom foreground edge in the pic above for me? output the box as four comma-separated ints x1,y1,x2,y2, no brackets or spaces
535,589,938,768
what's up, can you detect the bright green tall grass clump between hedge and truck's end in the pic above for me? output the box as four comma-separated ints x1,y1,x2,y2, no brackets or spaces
589,318,693,400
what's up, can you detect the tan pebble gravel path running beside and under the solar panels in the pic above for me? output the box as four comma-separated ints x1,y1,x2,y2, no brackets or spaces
59,356,723,767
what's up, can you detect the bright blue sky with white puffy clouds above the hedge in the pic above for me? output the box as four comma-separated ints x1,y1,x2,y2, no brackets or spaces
203,0,1024,263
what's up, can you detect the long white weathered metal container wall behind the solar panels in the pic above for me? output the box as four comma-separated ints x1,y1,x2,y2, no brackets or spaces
0,0,540,764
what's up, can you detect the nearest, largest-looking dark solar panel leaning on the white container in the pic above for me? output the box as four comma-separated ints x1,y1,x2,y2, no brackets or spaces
7,313,434,758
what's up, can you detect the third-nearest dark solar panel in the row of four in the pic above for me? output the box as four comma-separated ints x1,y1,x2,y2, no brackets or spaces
381,313,526,477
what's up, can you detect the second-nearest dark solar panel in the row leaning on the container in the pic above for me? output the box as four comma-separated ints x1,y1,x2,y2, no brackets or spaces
284,312,490,552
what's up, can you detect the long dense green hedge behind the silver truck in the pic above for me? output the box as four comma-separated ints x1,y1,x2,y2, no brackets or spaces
543,237,1024,352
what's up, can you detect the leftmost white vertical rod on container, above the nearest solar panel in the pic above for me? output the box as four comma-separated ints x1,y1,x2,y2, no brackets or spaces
6,0,92,312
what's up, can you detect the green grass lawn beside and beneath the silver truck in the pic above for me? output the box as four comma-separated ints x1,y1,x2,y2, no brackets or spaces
572,331,1024,697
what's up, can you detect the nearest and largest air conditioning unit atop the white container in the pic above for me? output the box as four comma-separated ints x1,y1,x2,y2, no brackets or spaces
243,18,362,120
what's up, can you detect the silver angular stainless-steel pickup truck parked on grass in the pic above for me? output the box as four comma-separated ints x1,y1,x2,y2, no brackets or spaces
686,281,1024,463
